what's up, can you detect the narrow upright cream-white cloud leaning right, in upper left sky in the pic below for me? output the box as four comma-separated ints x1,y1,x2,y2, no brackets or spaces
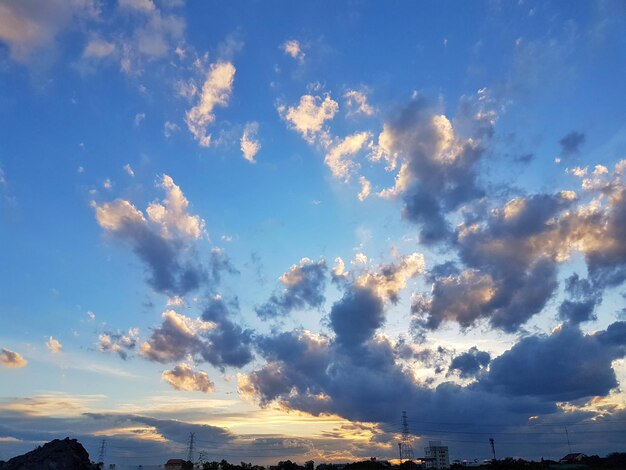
185,62,235,147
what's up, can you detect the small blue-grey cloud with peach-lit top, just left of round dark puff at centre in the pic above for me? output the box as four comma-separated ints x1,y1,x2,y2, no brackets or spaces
256,258,327,319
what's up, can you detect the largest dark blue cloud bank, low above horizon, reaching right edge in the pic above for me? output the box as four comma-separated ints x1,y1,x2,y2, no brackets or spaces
240,322,626,460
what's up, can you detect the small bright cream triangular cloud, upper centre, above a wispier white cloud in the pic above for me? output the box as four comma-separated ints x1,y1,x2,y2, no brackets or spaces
278,95,339,143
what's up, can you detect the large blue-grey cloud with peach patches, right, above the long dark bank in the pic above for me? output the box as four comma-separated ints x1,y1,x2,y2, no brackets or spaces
412,194,573,332
